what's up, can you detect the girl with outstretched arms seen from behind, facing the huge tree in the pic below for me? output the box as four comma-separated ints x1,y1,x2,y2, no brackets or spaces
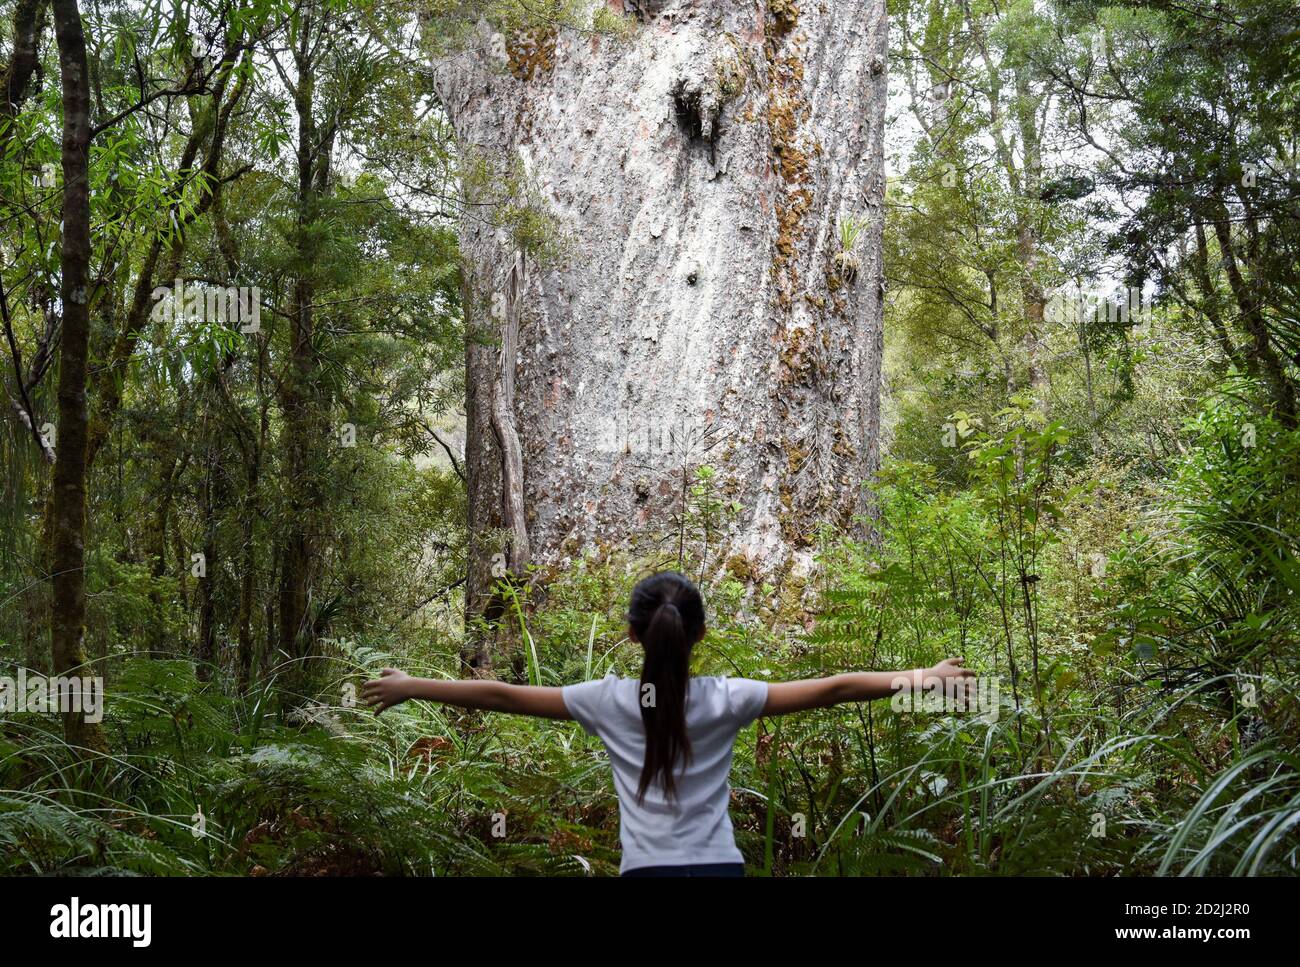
363,571,974,876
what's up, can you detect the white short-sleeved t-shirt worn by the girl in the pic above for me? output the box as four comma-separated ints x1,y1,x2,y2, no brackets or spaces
562,672,767,872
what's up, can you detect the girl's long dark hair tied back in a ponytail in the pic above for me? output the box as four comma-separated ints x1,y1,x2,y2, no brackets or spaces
628,571,705,802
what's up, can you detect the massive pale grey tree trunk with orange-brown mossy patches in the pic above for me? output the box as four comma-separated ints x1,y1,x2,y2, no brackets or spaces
436,0,887,611
